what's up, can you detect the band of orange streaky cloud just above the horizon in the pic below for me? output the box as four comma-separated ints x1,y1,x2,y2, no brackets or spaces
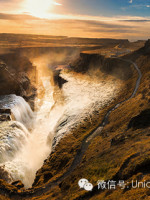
0,13,150,40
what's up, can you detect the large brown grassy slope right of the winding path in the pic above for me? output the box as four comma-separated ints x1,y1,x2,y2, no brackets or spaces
28,41,150,200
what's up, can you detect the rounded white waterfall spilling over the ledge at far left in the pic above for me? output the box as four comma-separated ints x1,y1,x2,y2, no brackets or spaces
0,94,33,163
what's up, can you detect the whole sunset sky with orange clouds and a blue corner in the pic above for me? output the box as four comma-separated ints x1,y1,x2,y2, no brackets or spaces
0,0,150,40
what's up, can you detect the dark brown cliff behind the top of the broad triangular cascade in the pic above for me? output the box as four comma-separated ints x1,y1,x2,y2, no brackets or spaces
69,53,132,80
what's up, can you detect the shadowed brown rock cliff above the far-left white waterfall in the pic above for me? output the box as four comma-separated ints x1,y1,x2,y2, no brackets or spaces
0,54,37,108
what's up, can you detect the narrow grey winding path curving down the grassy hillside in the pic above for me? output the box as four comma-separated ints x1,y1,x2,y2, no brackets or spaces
11,58,142,199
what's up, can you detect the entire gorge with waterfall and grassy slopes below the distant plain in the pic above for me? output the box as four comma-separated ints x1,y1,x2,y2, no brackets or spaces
0,34,150,200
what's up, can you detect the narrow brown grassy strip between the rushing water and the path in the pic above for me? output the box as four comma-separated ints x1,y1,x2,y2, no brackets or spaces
2,56,135,200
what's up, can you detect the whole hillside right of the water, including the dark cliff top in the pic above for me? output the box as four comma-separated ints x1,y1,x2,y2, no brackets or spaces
0,40,150,200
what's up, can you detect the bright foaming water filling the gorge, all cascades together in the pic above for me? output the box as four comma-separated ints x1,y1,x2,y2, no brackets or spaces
0,55,123,188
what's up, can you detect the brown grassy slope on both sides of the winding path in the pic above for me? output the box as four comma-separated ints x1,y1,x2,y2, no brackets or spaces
1,41,150,200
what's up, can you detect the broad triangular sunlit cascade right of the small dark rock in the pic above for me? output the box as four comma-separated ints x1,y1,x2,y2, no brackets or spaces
52,71,122,141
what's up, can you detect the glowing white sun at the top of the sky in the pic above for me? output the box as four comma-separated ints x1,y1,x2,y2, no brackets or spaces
23,0,61,18
